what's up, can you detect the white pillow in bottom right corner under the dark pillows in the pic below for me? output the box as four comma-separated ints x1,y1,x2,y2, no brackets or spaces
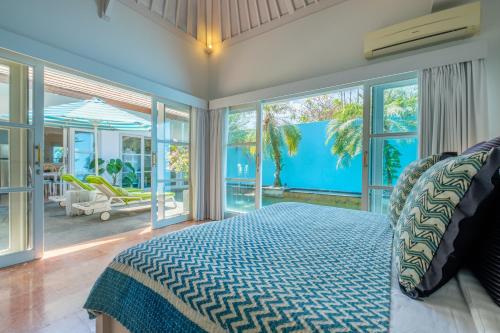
457,269,500,333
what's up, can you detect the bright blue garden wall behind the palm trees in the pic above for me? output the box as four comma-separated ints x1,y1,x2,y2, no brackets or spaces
226,121,417,193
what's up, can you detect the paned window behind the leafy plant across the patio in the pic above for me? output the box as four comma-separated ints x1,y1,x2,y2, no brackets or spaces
122,135,151,188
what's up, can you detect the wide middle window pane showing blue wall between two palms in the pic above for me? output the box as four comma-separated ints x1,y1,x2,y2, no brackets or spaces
262,87,363,209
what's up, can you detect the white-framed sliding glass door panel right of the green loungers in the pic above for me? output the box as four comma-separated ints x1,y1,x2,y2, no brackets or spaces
151,100,191,228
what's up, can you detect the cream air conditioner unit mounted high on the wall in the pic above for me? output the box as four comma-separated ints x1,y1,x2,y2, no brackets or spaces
364,2,481,59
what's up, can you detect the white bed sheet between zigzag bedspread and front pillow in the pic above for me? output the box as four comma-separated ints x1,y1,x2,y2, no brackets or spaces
390,262,477,333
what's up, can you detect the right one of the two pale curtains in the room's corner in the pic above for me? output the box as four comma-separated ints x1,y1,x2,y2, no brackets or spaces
208,108,227,220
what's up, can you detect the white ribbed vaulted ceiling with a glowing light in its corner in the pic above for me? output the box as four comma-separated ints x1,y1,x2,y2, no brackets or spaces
119,0,346,45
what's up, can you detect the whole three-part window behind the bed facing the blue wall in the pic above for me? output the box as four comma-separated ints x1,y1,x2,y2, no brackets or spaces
226,75,418,212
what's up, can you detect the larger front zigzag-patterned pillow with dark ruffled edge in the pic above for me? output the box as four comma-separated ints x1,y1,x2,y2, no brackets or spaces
394,152,489,298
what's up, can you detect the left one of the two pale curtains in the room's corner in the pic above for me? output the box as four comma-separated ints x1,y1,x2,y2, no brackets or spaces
190,108,209,221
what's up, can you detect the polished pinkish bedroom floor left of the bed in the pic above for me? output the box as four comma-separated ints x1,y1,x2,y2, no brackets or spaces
0,222,203,333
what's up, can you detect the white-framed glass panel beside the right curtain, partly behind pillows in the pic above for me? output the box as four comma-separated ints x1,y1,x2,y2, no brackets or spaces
368,74,418,213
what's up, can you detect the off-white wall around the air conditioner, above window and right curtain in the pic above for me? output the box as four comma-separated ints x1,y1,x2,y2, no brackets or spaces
209,0,500,137
